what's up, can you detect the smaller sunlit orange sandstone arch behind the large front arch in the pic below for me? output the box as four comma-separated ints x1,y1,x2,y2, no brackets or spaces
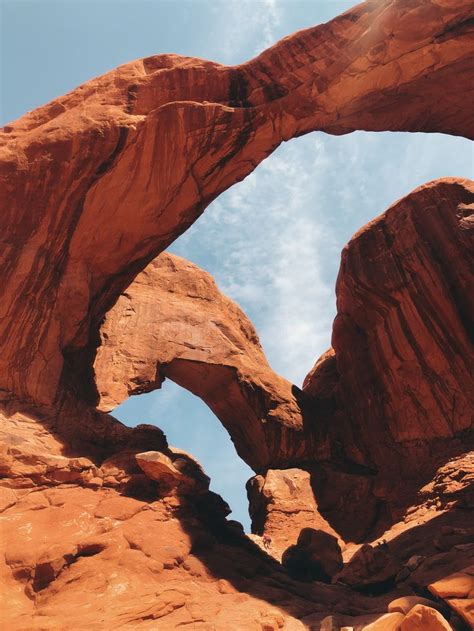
94,253,304,470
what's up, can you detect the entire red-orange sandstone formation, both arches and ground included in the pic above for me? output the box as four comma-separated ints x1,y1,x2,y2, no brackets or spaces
0,0,474,631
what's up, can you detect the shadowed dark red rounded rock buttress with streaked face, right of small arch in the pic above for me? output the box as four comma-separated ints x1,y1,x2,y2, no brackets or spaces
303,179,474,524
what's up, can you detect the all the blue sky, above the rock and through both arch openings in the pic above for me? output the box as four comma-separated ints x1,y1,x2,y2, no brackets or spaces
1,0,473,527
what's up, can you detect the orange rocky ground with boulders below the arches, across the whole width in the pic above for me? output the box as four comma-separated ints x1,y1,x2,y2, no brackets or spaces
0,407,474,631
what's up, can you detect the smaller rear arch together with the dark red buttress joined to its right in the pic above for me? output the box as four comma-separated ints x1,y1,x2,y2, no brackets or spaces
94,179,474,543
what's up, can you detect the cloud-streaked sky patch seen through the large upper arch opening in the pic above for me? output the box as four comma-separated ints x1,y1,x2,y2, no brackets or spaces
171,132,471,385
